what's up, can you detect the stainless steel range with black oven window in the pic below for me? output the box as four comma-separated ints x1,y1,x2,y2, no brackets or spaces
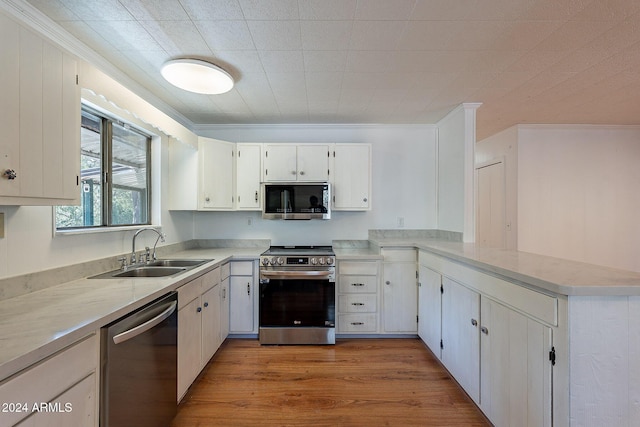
259,246,336,344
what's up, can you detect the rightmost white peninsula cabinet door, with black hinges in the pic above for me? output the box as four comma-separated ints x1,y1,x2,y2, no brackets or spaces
480,297,552,427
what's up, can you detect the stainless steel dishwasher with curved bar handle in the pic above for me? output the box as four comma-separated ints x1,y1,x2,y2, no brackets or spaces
100,292,178,427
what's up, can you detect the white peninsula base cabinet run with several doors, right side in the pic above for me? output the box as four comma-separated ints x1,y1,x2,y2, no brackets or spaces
419,251,566,427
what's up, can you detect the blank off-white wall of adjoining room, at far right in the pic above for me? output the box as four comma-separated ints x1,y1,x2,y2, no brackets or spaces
518,126,640,271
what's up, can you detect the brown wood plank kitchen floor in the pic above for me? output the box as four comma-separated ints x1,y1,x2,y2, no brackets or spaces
171,339,490,427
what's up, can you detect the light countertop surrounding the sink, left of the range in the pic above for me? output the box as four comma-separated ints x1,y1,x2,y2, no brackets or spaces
0,248,265,381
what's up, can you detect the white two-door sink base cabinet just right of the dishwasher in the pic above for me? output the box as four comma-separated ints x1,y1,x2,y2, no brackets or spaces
178,268,221,400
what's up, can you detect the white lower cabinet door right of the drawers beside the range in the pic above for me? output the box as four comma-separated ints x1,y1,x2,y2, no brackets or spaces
382,263,418,333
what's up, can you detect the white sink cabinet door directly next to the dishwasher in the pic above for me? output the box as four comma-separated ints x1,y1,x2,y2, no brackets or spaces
178,297,202,399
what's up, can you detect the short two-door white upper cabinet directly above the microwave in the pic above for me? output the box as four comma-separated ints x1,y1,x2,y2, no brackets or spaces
262,144,330,182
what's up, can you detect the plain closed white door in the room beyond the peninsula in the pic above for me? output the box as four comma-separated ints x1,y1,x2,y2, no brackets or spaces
476,162,507,248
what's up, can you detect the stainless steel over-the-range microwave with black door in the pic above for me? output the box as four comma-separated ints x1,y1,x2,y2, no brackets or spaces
262,182,331,219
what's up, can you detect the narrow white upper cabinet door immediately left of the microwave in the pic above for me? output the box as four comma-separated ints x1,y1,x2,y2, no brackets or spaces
236,144,262,210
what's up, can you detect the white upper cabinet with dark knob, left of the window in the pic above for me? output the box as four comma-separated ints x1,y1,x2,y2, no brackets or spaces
0,12,80,206
